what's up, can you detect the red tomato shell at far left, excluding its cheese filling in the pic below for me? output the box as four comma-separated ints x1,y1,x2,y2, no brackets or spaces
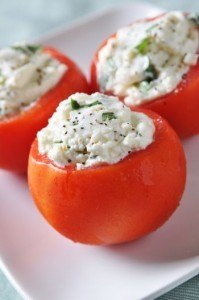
0,47,89,172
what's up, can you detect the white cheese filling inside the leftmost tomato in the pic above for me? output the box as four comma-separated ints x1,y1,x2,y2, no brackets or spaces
0,45,67,119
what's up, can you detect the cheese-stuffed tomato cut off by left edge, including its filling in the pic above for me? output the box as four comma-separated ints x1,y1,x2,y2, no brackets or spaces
0,45,88,172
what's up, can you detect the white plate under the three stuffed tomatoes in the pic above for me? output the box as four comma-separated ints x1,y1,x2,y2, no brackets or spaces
0,2,199,300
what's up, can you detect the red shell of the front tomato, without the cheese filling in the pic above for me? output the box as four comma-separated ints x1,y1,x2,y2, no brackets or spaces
28,111,186,245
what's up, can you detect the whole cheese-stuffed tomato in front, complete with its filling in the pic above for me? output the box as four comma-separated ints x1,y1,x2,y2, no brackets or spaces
28,93,186,245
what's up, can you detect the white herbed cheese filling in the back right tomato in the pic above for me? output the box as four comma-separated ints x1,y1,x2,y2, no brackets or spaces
97,12,199,105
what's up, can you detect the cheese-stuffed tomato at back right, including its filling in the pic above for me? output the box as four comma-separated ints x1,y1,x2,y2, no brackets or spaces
91,12,199,137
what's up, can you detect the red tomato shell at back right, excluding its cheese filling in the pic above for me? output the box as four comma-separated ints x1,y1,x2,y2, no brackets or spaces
91,15,199,138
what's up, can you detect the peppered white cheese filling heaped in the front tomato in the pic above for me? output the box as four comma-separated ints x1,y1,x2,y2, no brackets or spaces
37,93,155,170
